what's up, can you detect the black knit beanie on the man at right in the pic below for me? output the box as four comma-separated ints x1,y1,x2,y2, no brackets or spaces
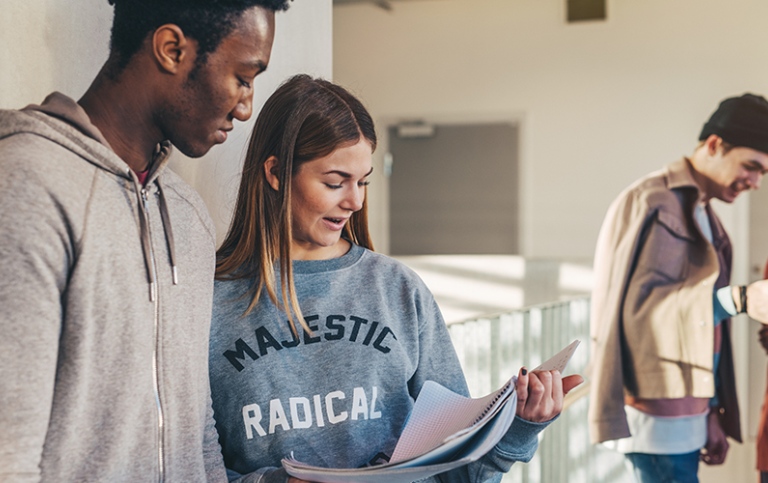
699,94,768,153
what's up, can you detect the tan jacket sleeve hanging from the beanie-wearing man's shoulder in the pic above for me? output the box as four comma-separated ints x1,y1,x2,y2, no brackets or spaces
588,187,649,443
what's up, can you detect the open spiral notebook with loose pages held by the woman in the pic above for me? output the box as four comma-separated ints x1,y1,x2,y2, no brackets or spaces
282,340,579,483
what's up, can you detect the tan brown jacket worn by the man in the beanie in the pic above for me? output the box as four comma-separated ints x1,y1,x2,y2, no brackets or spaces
589,159,741,443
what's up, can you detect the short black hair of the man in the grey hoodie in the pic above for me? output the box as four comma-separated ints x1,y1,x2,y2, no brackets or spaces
107,0,289,70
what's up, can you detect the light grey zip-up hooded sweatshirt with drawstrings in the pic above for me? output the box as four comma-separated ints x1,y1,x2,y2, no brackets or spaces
0,93,226,482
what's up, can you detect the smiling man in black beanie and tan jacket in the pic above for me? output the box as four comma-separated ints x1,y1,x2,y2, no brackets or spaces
589,94,768,482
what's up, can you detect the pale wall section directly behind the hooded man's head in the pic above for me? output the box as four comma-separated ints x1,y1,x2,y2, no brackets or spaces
0,0,332,240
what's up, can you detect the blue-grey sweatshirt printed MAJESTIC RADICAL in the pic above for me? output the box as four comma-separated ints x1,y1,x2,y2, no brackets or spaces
210,246,547,482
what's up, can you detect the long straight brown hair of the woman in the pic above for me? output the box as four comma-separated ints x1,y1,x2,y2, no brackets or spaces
216,74,376,333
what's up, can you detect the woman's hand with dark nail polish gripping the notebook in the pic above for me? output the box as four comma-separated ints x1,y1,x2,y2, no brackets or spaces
516,367,584,423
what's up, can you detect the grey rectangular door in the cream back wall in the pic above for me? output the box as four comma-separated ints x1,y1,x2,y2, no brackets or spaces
388,122,520,255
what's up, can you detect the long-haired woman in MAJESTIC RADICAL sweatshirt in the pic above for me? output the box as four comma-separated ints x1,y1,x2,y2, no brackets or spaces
210,75,581,482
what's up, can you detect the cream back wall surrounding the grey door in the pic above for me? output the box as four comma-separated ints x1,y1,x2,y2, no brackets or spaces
333,0,768,482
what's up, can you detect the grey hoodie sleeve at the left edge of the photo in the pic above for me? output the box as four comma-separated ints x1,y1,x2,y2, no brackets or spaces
0,147,76,482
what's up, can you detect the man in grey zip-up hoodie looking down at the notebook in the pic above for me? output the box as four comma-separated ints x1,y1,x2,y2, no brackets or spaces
0,0,287,482
